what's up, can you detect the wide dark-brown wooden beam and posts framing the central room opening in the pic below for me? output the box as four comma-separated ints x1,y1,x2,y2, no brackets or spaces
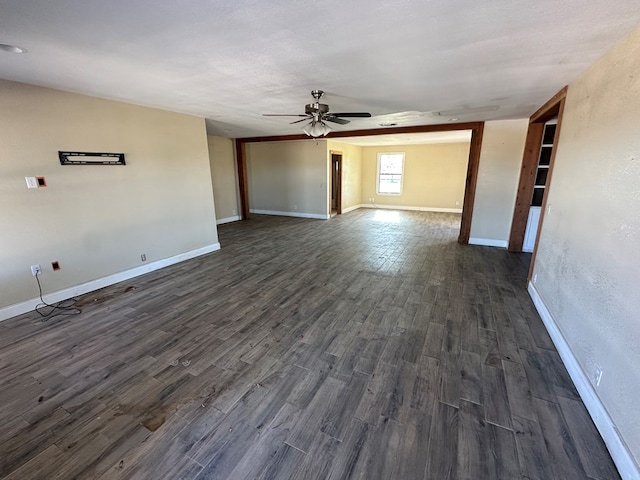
236,122,484,245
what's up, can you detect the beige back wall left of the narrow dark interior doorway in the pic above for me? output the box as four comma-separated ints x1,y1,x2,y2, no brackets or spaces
246,140,329,218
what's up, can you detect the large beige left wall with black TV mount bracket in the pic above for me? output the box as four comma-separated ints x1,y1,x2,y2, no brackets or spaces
0,80,218,307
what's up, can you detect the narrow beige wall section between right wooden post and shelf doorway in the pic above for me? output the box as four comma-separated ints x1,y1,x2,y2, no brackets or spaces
470,119,529,247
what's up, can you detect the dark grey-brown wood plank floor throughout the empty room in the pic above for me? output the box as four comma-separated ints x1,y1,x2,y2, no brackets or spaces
0,209,619,480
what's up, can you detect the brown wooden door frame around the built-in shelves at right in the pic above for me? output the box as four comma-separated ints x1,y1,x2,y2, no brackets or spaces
508,86,568,280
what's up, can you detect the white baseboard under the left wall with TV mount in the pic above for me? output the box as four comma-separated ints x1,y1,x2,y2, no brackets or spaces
0,243,220,321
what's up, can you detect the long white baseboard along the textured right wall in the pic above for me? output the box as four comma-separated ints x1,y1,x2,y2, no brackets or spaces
528,282,640,480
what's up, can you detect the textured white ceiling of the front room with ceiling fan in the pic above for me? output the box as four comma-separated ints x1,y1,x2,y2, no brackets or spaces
0,0,640,137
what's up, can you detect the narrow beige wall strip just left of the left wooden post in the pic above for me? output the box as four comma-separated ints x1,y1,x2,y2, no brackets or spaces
207,135,240,223
